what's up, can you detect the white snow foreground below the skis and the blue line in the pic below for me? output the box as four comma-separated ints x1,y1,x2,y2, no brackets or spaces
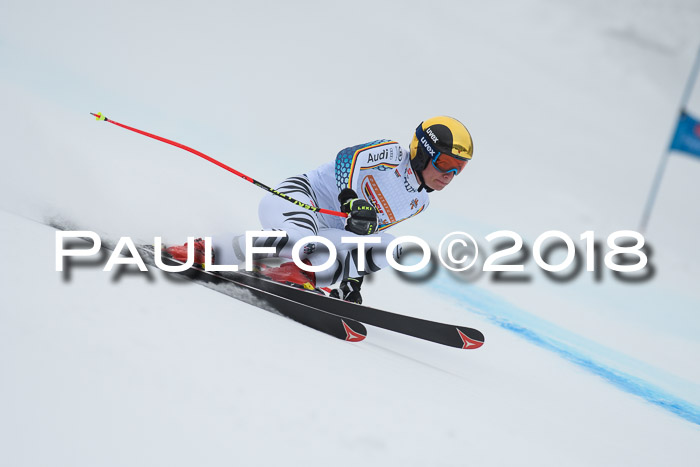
0,214,700,465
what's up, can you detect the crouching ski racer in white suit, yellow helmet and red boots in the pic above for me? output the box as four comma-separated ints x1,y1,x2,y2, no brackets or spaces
168,116,473,303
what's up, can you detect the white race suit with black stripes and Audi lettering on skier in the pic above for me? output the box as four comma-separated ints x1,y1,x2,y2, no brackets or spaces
214,140,429,287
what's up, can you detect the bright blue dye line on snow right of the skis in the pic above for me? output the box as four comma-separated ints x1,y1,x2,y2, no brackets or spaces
434,283,700,425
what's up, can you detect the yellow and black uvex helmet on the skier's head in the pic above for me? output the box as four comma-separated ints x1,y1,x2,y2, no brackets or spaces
410,117,474,182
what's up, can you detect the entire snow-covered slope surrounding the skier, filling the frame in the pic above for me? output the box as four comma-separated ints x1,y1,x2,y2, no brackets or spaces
0,0,700,466
